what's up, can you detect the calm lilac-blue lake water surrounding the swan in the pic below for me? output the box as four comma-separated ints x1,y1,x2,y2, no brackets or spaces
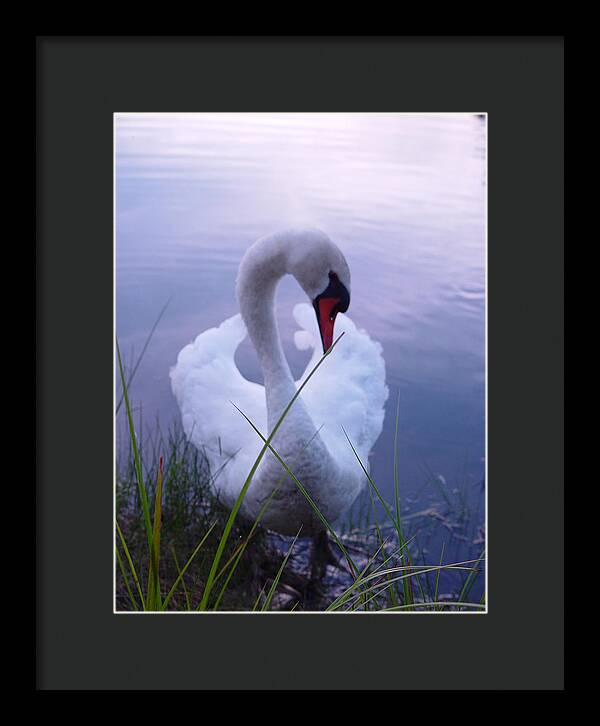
115,114,487,600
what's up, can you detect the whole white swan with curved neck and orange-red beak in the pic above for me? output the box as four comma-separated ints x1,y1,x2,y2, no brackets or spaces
170,230,388,536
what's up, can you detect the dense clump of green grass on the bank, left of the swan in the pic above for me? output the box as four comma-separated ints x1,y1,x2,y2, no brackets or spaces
115,426,278,611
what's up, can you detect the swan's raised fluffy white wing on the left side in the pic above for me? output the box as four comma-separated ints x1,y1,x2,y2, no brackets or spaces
170,315,267,499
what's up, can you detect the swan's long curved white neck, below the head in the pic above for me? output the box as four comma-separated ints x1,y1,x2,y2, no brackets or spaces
237,240,296,431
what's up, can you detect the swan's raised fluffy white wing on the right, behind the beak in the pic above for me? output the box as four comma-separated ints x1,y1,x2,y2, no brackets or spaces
294,303,388,470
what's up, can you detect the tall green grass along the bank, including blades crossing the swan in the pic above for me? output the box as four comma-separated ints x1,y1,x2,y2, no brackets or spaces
115,336,485,612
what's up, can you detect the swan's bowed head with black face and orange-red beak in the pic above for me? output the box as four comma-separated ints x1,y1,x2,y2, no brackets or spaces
288,230,350,353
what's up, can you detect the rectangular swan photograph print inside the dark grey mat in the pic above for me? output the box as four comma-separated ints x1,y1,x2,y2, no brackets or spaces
114,112,494,615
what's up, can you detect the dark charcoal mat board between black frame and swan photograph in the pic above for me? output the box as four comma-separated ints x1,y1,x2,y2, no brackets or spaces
36,36,564,690
